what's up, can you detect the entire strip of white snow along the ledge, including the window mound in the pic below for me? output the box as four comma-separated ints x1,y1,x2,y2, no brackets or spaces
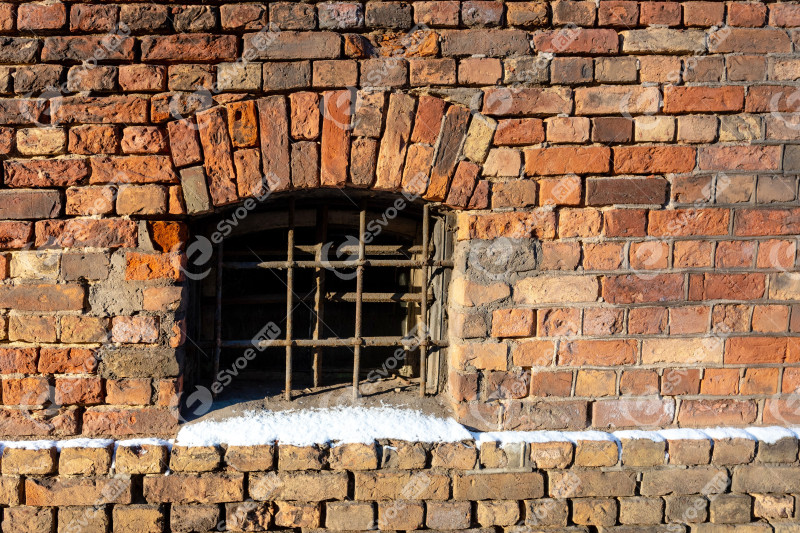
0,407,800,448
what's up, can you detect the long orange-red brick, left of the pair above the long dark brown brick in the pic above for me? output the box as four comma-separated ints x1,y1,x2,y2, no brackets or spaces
525,146,611,176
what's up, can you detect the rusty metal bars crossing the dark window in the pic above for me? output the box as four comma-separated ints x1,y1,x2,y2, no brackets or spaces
214,199,453,400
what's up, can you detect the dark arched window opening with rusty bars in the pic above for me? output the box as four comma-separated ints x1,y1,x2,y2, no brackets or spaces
184,194,453,401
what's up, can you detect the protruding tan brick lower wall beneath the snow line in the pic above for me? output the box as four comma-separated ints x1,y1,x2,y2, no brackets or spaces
0,437,800,533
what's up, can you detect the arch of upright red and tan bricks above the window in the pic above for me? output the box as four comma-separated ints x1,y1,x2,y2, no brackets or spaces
167,90,496,215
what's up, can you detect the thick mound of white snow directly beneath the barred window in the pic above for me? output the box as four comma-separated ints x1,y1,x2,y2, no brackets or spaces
175,407,472,446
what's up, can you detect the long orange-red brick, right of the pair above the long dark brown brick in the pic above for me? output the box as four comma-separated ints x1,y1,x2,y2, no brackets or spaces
614,146,695,174
